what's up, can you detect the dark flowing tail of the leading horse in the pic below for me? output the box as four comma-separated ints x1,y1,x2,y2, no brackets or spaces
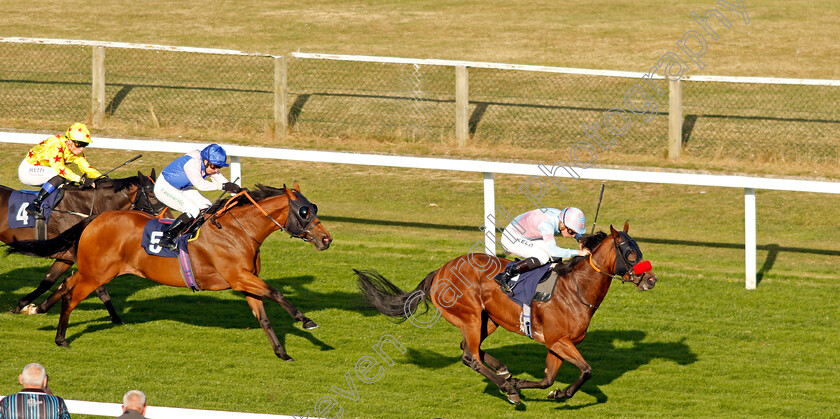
353,269,437,322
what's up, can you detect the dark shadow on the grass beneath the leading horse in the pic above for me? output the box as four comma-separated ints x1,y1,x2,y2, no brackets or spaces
406,330,697,410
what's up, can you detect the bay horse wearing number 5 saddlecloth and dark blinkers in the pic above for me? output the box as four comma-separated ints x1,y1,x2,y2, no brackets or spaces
9,182,332,360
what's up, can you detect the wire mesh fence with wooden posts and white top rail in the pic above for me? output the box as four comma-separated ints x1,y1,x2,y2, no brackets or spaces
0,37,840,162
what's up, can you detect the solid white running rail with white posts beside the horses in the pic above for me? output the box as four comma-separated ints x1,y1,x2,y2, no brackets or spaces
0,132,840,289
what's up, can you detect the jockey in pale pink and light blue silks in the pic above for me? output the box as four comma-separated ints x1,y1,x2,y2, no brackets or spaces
496,207,589,293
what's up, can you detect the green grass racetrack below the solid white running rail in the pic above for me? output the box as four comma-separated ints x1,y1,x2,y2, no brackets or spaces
0,145,840,418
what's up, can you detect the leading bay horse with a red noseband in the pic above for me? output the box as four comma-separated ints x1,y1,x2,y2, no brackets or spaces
356,223,656,404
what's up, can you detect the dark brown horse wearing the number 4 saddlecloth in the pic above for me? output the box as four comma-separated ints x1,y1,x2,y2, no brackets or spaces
0,169,166,323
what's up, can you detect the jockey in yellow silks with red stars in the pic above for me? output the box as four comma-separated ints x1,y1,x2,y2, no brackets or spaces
18,122,100,218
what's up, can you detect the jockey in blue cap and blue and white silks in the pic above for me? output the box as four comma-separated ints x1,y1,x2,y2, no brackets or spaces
155,144,241,250
